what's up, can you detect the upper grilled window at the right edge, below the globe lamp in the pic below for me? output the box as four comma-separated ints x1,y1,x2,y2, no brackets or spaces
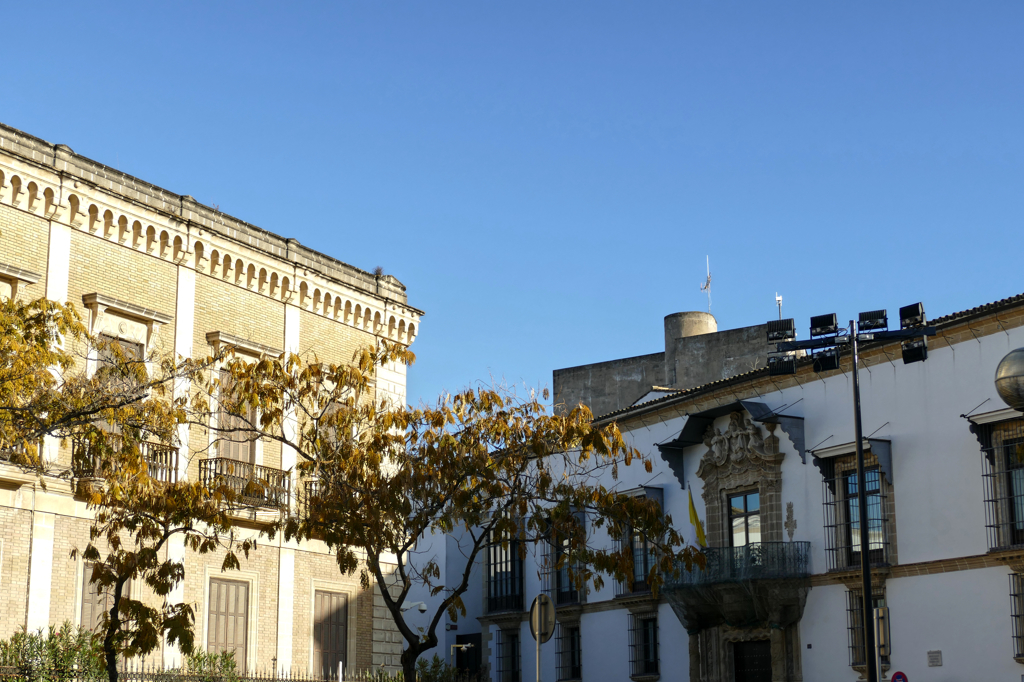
972,419,1024,550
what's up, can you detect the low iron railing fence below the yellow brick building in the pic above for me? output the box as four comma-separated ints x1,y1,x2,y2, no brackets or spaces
0,662,489,682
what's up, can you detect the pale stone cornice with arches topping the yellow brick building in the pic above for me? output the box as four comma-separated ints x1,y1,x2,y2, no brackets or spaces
0,124,423,345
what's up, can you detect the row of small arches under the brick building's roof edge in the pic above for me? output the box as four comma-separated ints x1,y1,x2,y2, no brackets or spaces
0,170,416,344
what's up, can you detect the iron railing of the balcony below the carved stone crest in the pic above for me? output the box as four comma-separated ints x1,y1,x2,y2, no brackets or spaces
666,542,811,587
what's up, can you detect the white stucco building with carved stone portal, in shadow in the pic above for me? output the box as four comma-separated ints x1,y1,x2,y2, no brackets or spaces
444,295,1024,682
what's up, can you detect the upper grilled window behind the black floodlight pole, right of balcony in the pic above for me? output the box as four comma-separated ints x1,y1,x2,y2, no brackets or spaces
819,458,891,570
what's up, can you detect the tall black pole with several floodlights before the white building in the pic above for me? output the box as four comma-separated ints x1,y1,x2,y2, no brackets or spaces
768,303,935,682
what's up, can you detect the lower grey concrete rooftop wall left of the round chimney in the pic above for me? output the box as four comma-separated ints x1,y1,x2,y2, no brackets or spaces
552,353,665,416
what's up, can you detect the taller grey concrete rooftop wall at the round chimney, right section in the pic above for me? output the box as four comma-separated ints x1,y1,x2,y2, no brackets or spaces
667,325,774,387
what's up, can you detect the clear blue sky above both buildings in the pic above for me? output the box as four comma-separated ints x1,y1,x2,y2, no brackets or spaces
0,0,1024,401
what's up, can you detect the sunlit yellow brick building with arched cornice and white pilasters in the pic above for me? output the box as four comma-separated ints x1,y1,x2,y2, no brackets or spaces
0,125,423,672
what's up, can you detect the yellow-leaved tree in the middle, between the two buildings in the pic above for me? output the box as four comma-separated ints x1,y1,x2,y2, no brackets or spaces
208,342,698,680
